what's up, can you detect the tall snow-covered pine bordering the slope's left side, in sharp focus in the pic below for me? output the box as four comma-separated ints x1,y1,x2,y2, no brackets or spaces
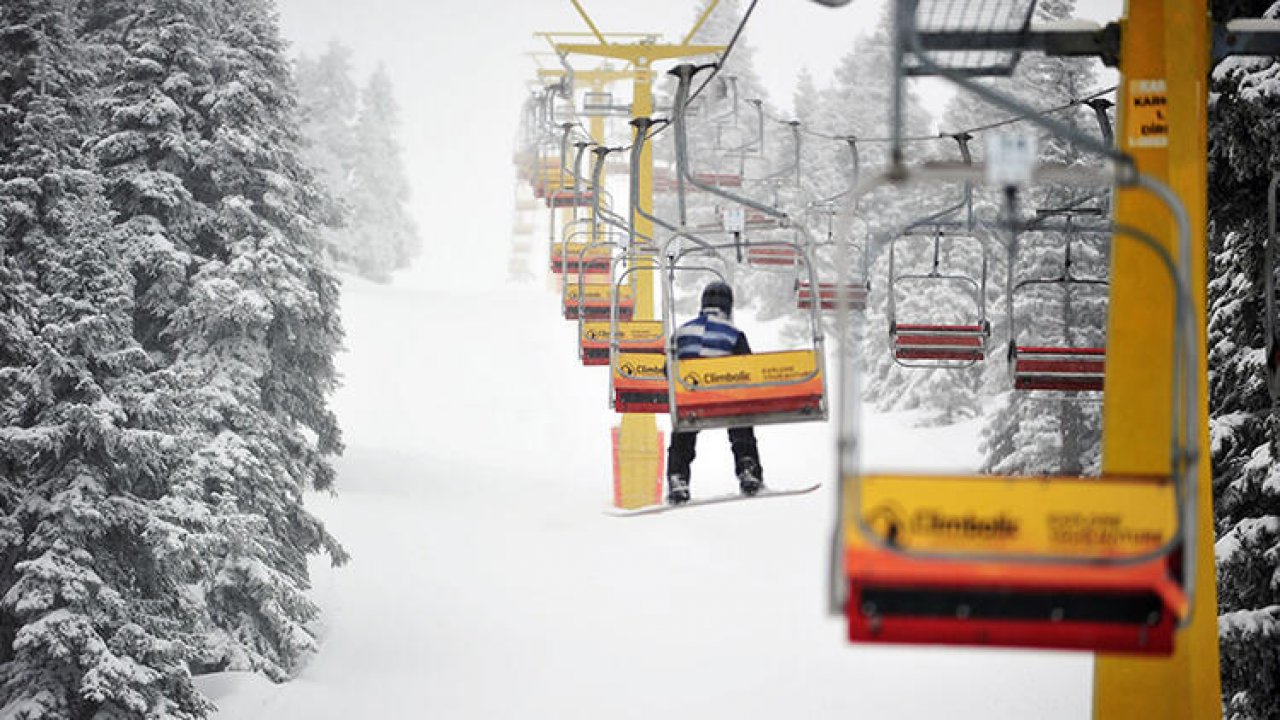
170,0,346,679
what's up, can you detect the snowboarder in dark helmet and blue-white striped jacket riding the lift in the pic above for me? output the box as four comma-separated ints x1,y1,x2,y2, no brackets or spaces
667,281,764,505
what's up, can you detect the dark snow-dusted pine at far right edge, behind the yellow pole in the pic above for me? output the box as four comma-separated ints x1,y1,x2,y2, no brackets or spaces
1208,3,1280,720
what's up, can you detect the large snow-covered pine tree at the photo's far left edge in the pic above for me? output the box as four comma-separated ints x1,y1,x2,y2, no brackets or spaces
0,0,211,720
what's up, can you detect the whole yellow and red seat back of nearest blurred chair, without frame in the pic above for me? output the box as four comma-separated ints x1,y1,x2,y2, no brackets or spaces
844,475,1189,655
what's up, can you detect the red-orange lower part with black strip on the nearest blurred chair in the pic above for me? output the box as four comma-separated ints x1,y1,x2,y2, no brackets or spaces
845,548,1185,655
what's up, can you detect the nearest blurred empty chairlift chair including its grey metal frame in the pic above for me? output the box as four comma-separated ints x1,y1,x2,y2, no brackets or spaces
832,0,1212,655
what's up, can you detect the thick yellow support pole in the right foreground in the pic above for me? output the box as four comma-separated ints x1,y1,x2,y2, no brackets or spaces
1093,0,1221,720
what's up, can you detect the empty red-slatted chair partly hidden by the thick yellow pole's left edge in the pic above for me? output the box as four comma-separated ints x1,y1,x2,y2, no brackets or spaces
1009,225,1107,392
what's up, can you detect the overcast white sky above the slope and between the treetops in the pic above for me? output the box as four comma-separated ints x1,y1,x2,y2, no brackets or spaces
272,0,1121,285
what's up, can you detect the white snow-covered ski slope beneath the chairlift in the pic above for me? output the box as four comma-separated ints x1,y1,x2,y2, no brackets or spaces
200,271,1092,720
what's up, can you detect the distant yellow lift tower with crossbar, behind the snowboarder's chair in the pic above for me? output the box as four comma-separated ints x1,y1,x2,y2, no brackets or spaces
539,0,724,509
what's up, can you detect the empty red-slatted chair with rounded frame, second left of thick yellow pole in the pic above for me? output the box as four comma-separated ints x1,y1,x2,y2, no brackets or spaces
888,225,991,368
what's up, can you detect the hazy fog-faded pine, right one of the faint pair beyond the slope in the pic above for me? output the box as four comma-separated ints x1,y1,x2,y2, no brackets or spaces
339,65,422,282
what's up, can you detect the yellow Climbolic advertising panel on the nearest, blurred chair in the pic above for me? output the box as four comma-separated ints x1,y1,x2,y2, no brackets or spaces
845,475,1178,559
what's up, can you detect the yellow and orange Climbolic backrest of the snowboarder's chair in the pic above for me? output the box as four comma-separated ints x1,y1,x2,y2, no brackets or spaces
672,350,827,430
